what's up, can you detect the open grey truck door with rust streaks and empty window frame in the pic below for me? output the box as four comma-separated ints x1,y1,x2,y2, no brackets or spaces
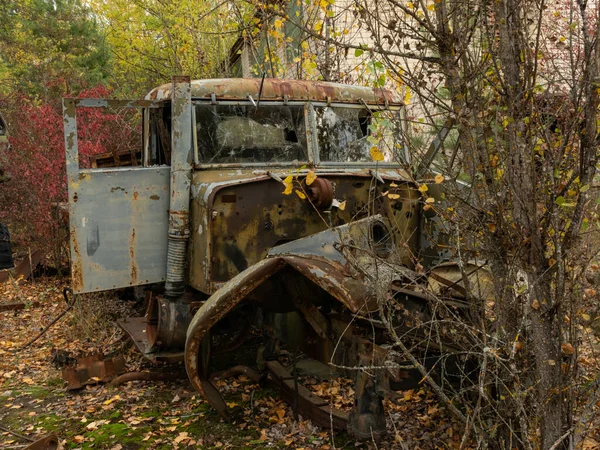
63,98,170,293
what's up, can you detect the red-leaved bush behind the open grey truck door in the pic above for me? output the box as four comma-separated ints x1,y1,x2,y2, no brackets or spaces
0,85,140,265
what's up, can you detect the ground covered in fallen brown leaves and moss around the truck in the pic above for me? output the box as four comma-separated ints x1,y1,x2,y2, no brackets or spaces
0,278,472,450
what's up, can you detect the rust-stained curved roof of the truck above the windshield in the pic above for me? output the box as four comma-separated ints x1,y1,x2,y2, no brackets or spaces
146,78,403,107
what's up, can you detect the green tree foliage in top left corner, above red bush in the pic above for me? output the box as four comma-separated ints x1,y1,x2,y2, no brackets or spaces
0,0,110,99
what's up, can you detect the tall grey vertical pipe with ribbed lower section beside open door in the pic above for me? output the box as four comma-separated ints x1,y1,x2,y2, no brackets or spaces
165,76,193,301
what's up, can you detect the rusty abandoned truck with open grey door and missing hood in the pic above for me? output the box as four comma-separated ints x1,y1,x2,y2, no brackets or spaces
63,77,482,439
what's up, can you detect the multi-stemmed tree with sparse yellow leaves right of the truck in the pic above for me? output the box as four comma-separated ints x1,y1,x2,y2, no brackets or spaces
244,0,600,449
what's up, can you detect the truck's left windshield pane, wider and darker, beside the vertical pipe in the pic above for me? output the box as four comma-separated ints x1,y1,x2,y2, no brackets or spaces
196,105,308,164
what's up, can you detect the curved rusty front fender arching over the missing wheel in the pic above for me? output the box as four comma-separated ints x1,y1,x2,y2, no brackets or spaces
185,216,389,416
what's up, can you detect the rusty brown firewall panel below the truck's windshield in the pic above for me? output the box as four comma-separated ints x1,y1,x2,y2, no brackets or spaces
189,168,420,294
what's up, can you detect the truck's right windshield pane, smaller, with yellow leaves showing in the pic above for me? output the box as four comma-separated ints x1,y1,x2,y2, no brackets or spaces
315,106,404,162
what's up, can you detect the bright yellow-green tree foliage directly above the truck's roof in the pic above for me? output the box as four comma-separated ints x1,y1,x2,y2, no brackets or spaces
92,0,237,96
